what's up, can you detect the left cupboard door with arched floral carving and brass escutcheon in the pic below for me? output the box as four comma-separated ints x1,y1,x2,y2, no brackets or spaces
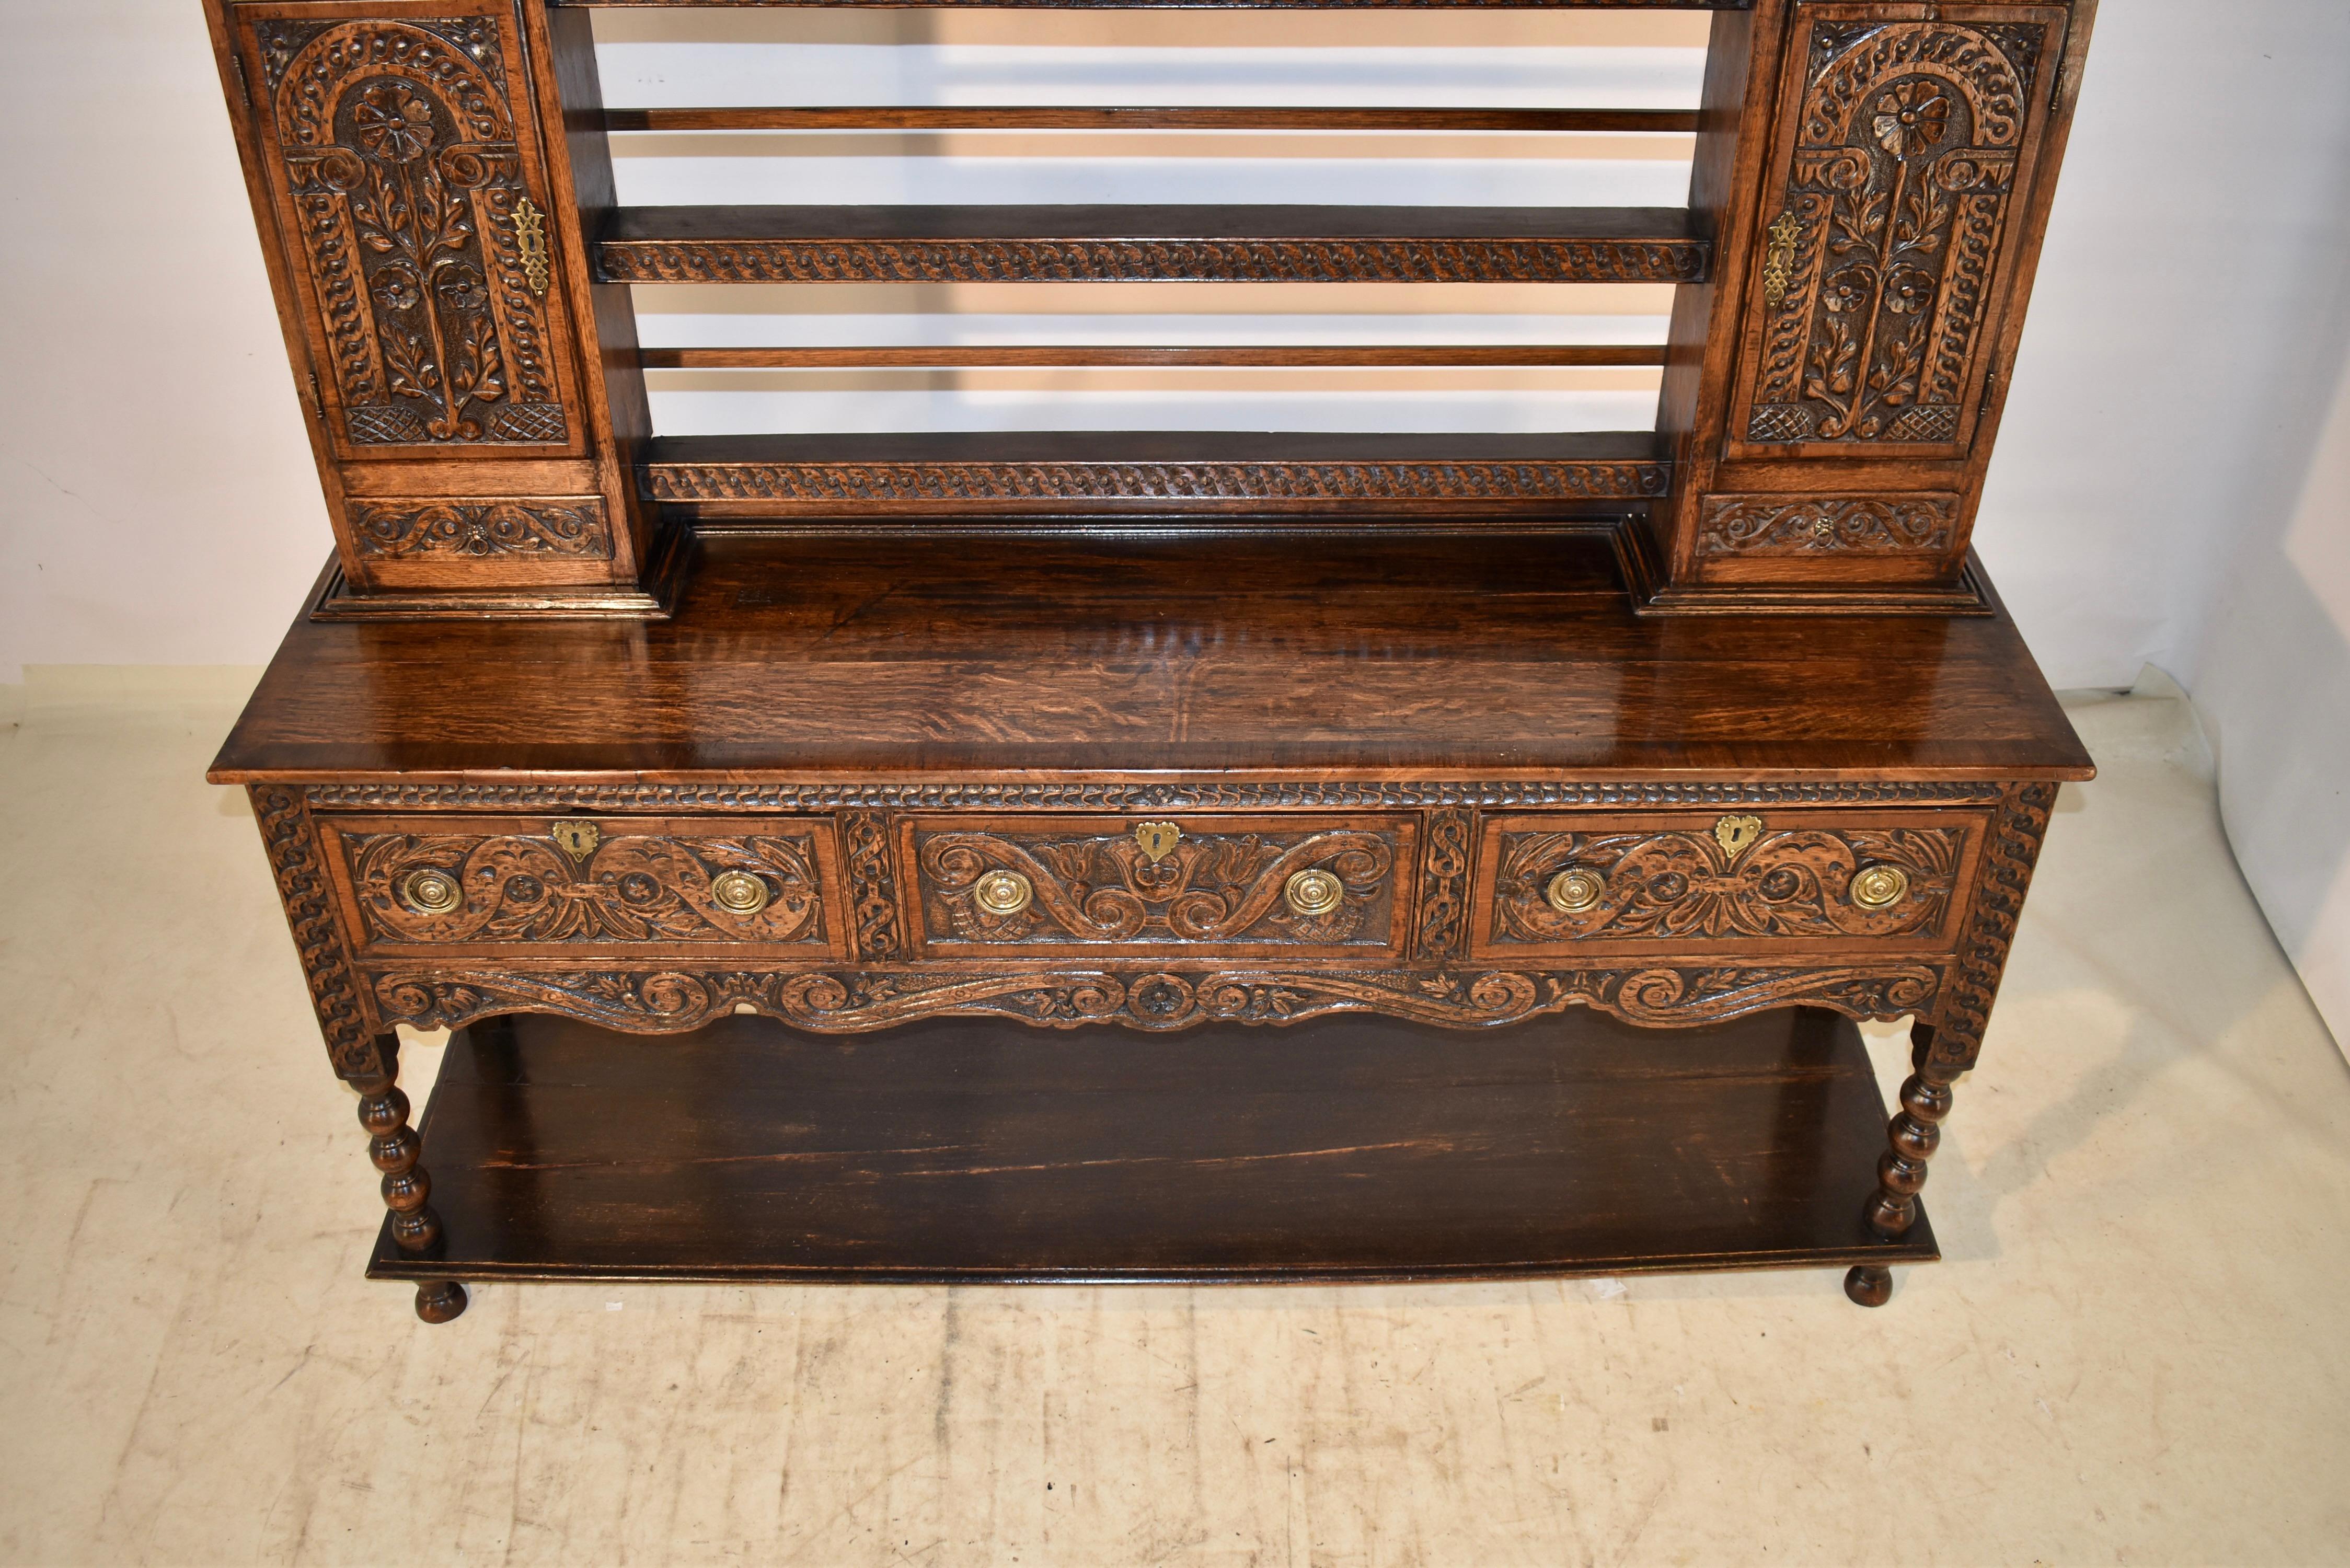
226,0,585,461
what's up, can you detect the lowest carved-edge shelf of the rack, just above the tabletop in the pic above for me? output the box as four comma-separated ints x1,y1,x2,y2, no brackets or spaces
644,430,1673,515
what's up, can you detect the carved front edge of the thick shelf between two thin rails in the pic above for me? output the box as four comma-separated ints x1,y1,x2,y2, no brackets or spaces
597,237,1709,282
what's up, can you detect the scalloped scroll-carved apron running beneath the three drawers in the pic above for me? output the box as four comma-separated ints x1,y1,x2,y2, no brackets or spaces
374,964,1941,1034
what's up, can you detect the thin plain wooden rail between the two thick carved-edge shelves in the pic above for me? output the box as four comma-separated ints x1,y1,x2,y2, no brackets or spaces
639,343,1664,369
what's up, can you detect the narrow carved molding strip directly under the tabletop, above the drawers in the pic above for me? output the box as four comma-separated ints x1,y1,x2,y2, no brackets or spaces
308,778,2007,809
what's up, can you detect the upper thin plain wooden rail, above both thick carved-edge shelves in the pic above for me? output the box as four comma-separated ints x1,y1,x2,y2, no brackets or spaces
604,103,1697,134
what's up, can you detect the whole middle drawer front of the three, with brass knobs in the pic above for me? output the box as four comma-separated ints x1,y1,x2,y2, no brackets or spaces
897,813,1420,959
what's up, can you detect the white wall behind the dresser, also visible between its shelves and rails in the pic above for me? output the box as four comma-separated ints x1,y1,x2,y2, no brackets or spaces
0,0,2350,1034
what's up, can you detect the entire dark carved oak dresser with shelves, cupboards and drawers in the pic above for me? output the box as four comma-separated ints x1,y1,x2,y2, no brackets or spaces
207,0,2091,1321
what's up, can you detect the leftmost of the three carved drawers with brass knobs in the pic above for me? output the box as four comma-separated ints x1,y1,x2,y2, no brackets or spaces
319,816,846,959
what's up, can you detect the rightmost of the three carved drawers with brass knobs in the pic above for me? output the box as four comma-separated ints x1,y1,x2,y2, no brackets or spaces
1471,811,1988,959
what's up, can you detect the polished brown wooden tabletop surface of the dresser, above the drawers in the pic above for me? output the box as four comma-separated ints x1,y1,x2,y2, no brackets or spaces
212,534,2089,783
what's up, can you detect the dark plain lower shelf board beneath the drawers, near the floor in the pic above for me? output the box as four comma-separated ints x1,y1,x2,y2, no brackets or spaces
369,1009,1939,1284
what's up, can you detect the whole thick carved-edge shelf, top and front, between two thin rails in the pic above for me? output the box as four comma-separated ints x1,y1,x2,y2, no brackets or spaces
597,204,1711,282
